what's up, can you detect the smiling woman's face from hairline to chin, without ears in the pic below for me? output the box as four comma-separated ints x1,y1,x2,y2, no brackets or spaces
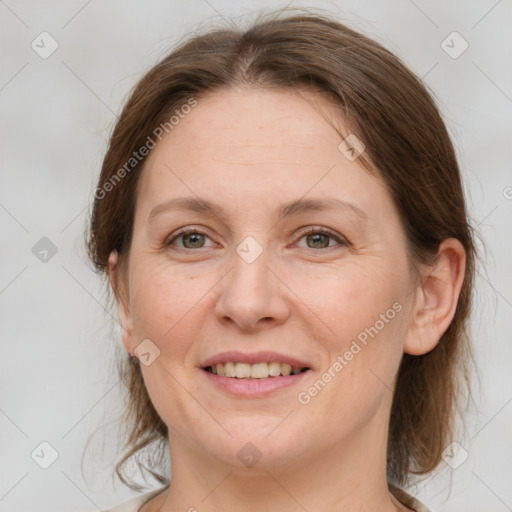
116,86,420,467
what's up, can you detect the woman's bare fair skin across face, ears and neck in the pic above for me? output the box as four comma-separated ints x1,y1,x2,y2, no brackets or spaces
110,89,465,512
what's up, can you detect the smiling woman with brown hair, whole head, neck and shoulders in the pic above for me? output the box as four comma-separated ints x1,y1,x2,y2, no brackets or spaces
88,8,474,512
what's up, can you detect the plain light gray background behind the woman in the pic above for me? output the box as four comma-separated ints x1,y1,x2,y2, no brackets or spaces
0,0,512,512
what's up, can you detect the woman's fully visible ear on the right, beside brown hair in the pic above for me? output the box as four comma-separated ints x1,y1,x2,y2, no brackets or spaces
404,238,466,356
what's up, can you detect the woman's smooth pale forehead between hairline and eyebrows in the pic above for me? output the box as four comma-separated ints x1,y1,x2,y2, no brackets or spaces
135,89,389,222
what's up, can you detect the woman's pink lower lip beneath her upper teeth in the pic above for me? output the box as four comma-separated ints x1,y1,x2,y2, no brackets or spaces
201,369,311,398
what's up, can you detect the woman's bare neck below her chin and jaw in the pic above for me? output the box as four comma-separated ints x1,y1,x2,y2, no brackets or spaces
150,400,409,512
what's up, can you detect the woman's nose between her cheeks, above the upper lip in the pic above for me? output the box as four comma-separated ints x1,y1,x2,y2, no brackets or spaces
215,243,290,331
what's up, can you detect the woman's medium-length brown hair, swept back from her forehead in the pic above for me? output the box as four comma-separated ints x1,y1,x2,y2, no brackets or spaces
87,7,475,489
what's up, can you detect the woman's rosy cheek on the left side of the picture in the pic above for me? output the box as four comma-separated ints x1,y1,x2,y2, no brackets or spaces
131,258,207,422
